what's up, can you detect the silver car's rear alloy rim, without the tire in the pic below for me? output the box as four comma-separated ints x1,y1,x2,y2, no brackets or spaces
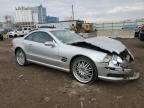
16,50,26,66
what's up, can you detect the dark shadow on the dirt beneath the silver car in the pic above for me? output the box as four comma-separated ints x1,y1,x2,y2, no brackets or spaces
25,63,136,86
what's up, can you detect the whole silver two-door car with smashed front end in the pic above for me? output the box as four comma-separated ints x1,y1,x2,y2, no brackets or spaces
12,29,139,83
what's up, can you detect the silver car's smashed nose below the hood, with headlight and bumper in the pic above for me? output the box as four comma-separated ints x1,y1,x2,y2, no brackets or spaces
97,49,139,81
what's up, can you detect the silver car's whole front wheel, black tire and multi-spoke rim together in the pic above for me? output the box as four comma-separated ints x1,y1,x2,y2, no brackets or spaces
71,57,98,84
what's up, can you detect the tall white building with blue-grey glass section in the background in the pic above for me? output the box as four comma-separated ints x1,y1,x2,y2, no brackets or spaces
15,5,46,26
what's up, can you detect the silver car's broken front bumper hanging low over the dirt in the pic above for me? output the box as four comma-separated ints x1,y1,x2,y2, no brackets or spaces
97,63,140,81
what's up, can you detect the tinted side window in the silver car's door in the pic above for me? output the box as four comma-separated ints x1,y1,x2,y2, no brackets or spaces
25,32,53,43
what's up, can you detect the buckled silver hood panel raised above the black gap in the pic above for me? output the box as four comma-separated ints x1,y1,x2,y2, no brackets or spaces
73,37,126,54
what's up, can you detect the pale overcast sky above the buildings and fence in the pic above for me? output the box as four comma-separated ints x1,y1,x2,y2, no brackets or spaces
0,0,144,22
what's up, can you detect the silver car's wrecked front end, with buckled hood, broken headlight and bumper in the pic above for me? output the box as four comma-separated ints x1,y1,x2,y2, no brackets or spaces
71,37,140,81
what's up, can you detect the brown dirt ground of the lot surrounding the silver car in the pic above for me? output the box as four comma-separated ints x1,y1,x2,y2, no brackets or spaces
0,39,144,108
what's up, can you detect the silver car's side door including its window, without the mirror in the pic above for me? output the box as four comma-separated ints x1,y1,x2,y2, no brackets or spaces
26,31,59,66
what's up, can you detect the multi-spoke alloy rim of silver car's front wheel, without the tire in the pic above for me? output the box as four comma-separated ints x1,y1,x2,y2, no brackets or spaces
73,60,93,83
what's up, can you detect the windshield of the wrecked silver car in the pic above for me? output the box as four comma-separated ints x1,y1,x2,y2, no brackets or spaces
51,30,84,44
